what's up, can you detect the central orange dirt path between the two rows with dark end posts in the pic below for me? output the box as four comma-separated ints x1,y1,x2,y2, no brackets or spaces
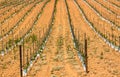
28,0,84,77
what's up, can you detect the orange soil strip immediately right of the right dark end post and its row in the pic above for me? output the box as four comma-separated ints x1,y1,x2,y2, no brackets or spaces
67,1,120,77
